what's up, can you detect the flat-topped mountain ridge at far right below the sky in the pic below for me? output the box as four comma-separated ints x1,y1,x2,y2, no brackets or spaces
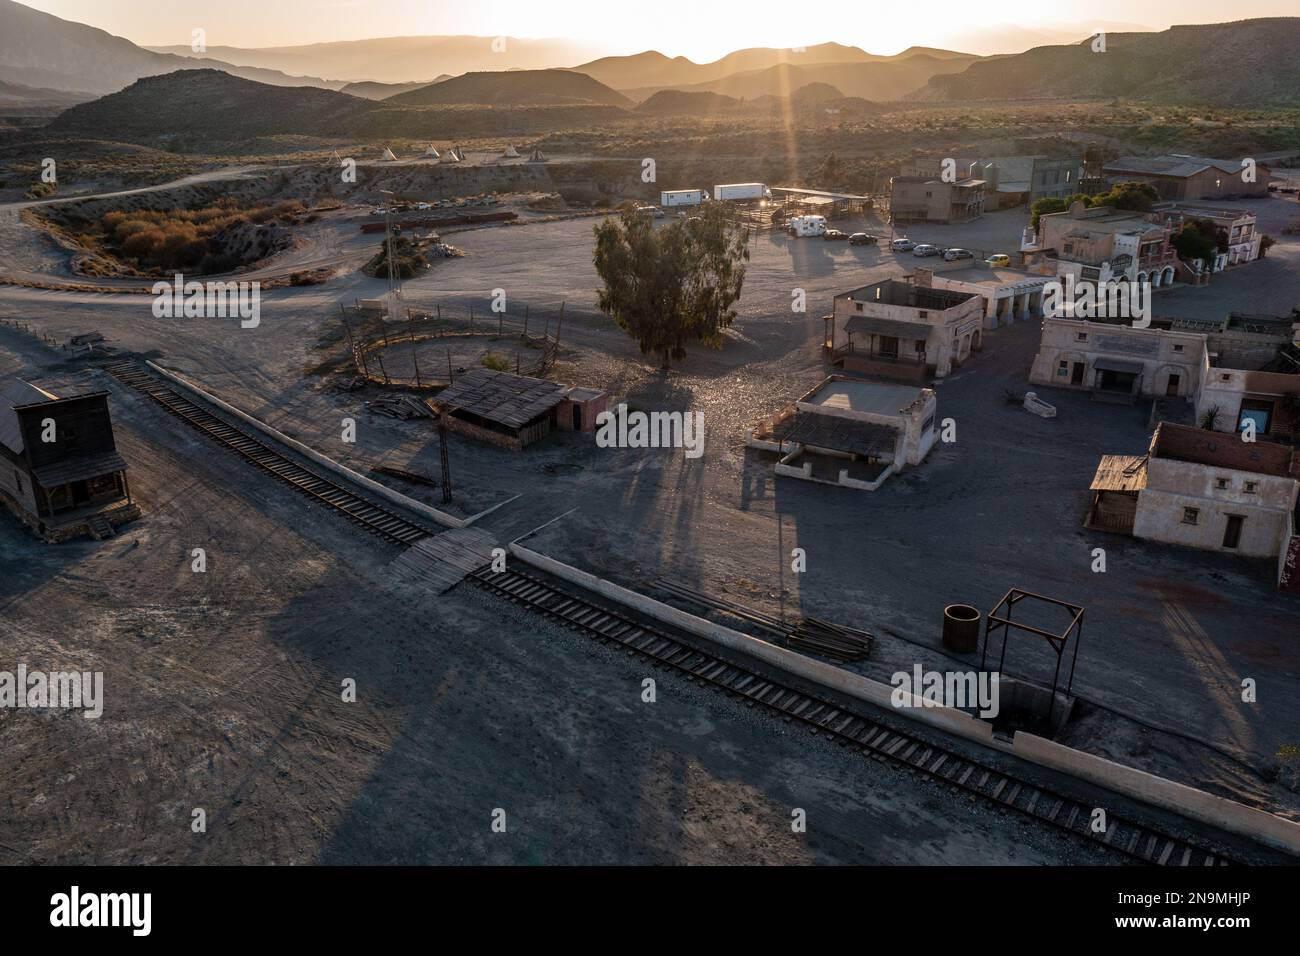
914,17,1300,107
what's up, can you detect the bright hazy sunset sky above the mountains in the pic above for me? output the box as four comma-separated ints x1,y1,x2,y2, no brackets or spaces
17,0,1297,60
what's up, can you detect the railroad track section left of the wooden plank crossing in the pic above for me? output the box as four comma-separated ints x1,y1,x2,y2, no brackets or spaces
105,362,433,545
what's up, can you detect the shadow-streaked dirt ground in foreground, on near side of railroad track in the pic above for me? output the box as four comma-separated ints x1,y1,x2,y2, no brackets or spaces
0,330,1133,864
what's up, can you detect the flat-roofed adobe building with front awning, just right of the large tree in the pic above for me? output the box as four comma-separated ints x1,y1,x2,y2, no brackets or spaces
823,269,985,382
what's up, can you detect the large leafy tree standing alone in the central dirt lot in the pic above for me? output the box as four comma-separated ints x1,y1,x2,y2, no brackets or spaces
593,203,749,368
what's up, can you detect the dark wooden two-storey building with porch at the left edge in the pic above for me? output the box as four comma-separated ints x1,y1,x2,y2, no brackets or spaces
0,378,140,541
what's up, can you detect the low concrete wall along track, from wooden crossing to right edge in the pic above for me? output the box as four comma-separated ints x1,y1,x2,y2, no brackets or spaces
510,544,1300,856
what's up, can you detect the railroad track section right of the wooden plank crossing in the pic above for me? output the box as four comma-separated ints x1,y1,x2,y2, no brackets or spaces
468,567,1232,866
